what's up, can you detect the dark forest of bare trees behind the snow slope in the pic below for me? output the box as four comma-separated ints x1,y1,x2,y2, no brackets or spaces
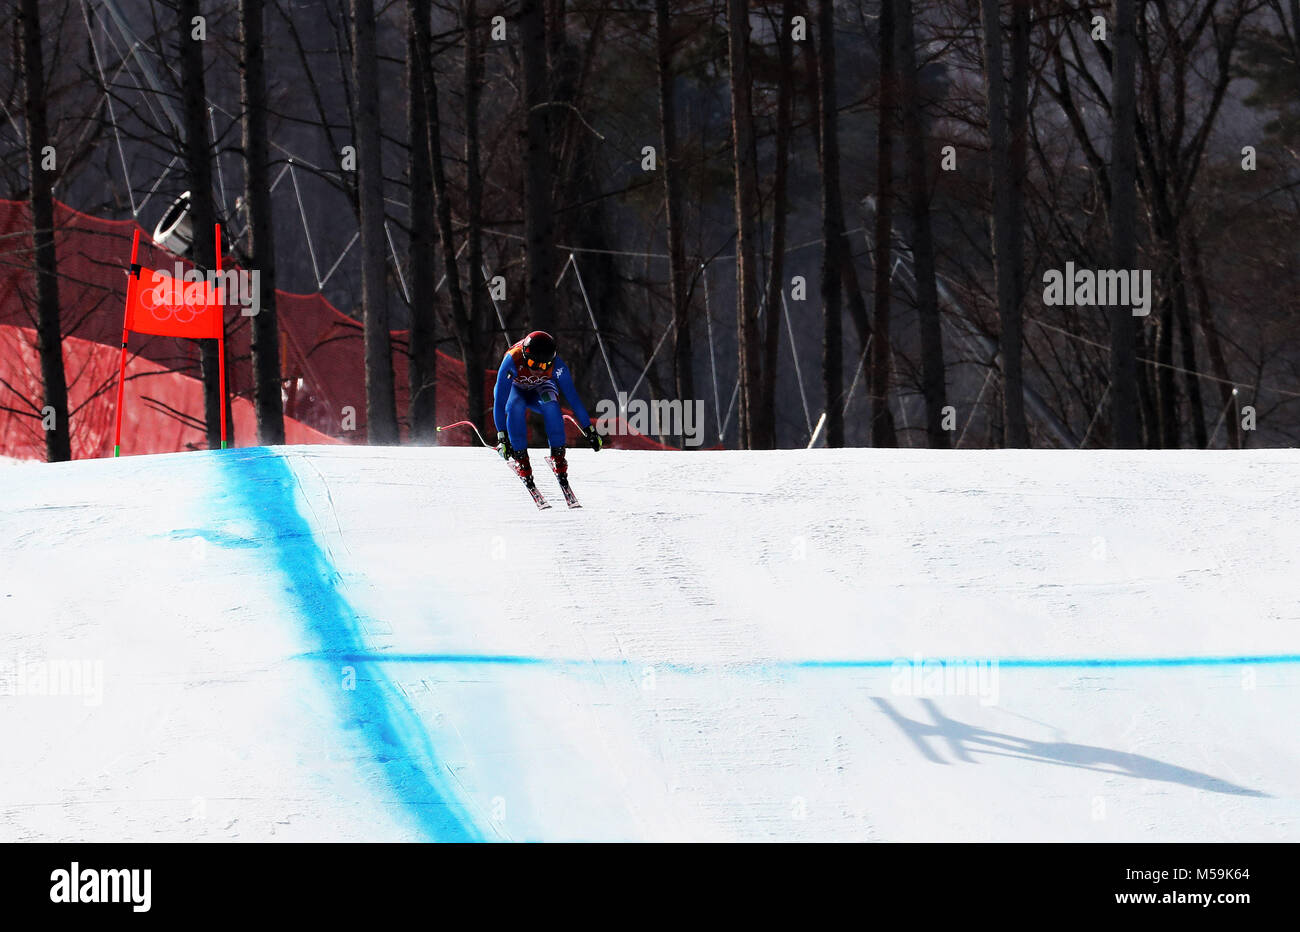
0,0,1300,459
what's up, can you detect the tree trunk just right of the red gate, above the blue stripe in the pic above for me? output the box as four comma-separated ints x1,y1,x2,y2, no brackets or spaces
239,0,285,445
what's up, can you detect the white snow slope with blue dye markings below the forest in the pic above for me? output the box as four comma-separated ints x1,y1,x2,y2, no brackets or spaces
0,447,1300,841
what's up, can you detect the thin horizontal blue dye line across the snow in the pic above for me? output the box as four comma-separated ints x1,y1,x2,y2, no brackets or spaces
298,651,1300,673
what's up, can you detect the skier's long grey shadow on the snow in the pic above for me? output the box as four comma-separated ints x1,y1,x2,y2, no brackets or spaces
872,697,1269,798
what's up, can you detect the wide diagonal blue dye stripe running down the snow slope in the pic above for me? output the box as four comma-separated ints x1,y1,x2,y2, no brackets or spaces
218,447,482,841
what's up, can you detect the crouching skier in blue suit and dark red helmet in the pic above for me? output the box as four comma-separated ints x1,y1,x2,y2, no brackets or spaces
493,330,605,485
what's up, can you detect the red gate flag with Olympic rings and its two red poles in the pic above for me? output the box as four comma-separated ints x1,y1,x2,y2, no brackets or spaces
113,224,226,456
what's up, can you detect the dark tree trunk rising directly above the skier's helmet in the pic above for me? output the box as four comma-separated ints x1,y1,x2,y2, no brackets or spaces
519,0,555,331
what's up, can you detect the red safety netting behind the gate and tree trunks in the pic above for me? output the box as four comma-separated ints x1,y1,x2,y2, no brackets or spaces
0,199,686,459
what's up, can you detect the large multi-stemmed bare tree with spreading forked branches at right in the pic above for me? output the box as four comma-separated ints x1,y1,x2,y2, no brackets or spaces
1043,0,1258,447
